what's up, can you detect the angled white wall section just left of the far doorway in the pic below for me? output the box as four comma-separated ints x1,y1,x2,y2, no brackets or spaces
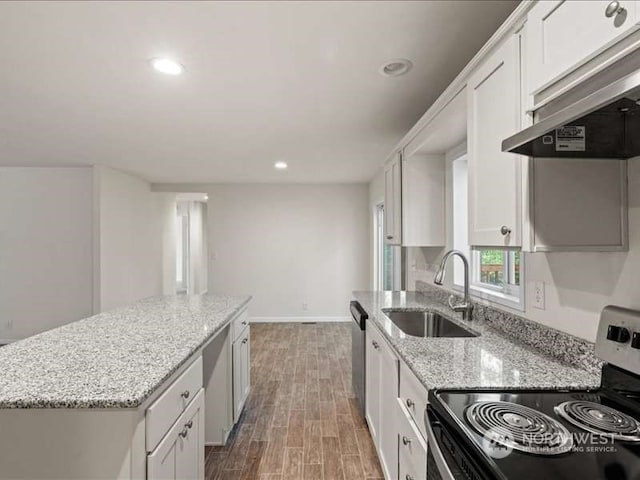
95,167,175,311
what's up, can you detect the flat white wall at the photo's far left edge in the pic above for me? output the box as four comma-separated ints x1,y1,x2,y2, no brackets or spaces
0,167,93,340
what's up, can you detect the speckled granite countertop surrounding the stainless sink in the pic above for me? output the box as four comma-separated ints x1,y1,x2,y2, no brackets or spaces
354,292,600,389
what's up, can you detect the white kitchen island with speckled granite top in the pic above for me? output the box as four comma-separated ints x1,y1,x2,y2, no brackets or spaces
0,295,251,479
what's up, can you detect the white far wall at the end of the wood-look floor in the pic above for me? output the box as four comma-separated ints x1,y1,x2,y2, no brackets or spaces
198,184,369,321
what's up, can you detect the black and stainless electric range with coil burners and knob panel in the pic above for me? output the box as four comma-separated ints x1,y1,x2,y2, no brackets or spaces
425,307,640,480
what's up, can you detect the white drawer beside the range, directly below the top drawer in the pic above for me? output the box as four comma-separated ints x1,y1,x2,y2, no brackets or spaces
398,399,427,480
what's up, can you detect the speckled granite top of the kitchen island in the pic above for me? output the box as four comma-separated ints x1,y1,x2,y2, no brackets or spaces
0,294,251,409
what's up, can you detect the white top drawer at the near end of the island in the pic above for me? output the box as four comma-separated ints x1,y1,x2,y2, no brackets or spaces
146,356,202,452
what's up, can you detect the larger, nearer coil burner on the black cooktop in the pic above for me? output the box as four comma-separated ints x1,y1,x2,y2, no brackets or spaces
465,401,573,455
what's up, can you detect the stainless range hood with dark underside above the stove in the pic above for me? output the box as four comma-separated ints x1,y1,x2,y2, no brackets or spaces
502,69,640,159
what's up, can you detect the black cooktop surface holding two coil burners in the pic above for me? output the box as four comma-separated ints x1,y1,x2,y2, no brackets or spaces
429,390,640,480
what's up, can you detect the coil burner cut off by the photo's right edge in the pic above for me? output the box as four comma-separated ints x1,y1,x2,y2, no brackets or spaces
555,400,640,442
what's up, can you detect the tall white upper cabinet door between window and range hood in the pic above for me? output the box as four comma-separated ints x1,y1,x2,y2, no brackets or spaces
467,36,522,248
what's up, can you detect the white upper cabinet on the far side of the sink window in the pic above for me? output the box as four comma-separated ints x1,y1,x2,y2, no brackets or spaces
385,153,445,247
